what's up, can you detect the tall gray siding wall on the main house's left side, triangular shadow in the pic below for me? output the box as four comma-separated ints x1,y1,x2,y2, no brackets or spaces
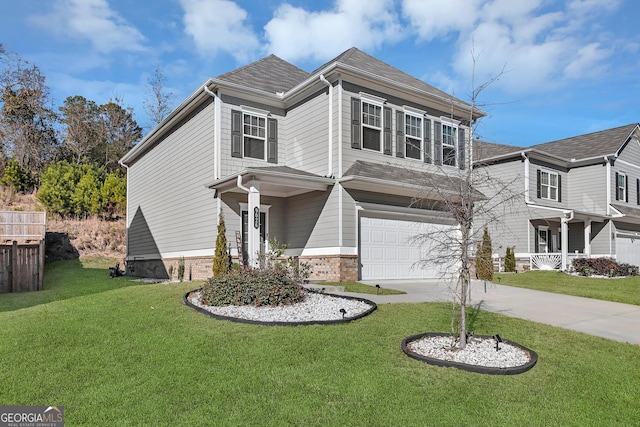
127,98,216,256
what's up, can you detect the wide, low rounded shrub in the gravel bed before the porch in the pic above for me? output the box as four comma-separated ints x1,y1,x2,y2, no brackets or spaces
201,268,304,307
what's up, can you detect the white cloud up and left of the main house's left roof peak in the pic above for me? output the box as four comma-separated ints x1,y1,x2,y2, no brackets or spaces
180,0,260,62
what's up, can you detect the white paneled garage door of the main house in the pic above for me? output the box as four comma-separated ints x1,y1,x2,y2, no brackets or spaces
360,217,455,280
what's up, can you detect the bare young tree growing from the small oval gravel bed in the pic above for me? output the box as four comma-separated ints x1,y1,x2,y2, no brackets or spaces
413,54,519,349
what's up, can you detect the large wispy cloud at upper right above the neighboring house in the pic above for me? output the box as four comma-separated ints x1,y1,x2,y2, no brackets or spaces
402,0,620,94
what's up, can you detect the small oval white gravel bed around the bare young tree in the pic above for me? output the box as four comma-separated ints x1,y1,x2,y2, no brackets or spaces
407,336,530,368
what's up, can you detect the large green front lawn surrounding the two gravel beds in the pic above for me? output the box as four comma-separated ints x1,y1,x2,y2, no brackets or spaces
0,261,640,426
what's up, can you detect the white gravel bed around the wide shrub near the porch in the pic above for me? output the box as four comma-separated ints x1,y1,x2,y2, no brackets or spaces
188,292,372,322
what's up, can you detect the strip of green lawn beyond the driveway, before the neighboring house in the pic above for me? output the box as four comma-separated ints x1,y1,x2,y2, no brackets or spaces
493,271,640,305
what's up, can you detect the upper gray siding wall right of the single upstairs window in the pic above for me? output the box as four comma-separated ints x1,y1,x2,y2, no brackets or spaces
286,88,338,176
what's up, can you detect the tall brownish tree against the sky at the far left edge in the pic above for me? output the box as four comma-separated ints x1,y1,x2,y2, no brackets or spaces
0,47,58,175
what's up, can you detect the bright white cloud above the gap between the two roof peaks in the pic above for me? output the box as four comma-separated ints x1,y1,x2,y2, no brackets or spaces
264,0,406,61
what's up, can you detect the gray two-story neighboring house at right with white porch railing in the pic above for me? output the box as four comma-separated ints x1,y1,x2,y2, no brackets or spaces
474,123,640,269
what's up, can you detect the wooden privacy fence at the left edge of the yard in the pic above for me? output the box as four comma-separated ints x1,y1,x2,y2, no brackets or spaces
0,211,46,293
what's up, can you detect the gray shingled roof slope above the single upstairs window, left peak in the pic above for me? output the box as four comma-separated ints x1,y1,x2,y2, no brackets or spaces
216,55,309,93
